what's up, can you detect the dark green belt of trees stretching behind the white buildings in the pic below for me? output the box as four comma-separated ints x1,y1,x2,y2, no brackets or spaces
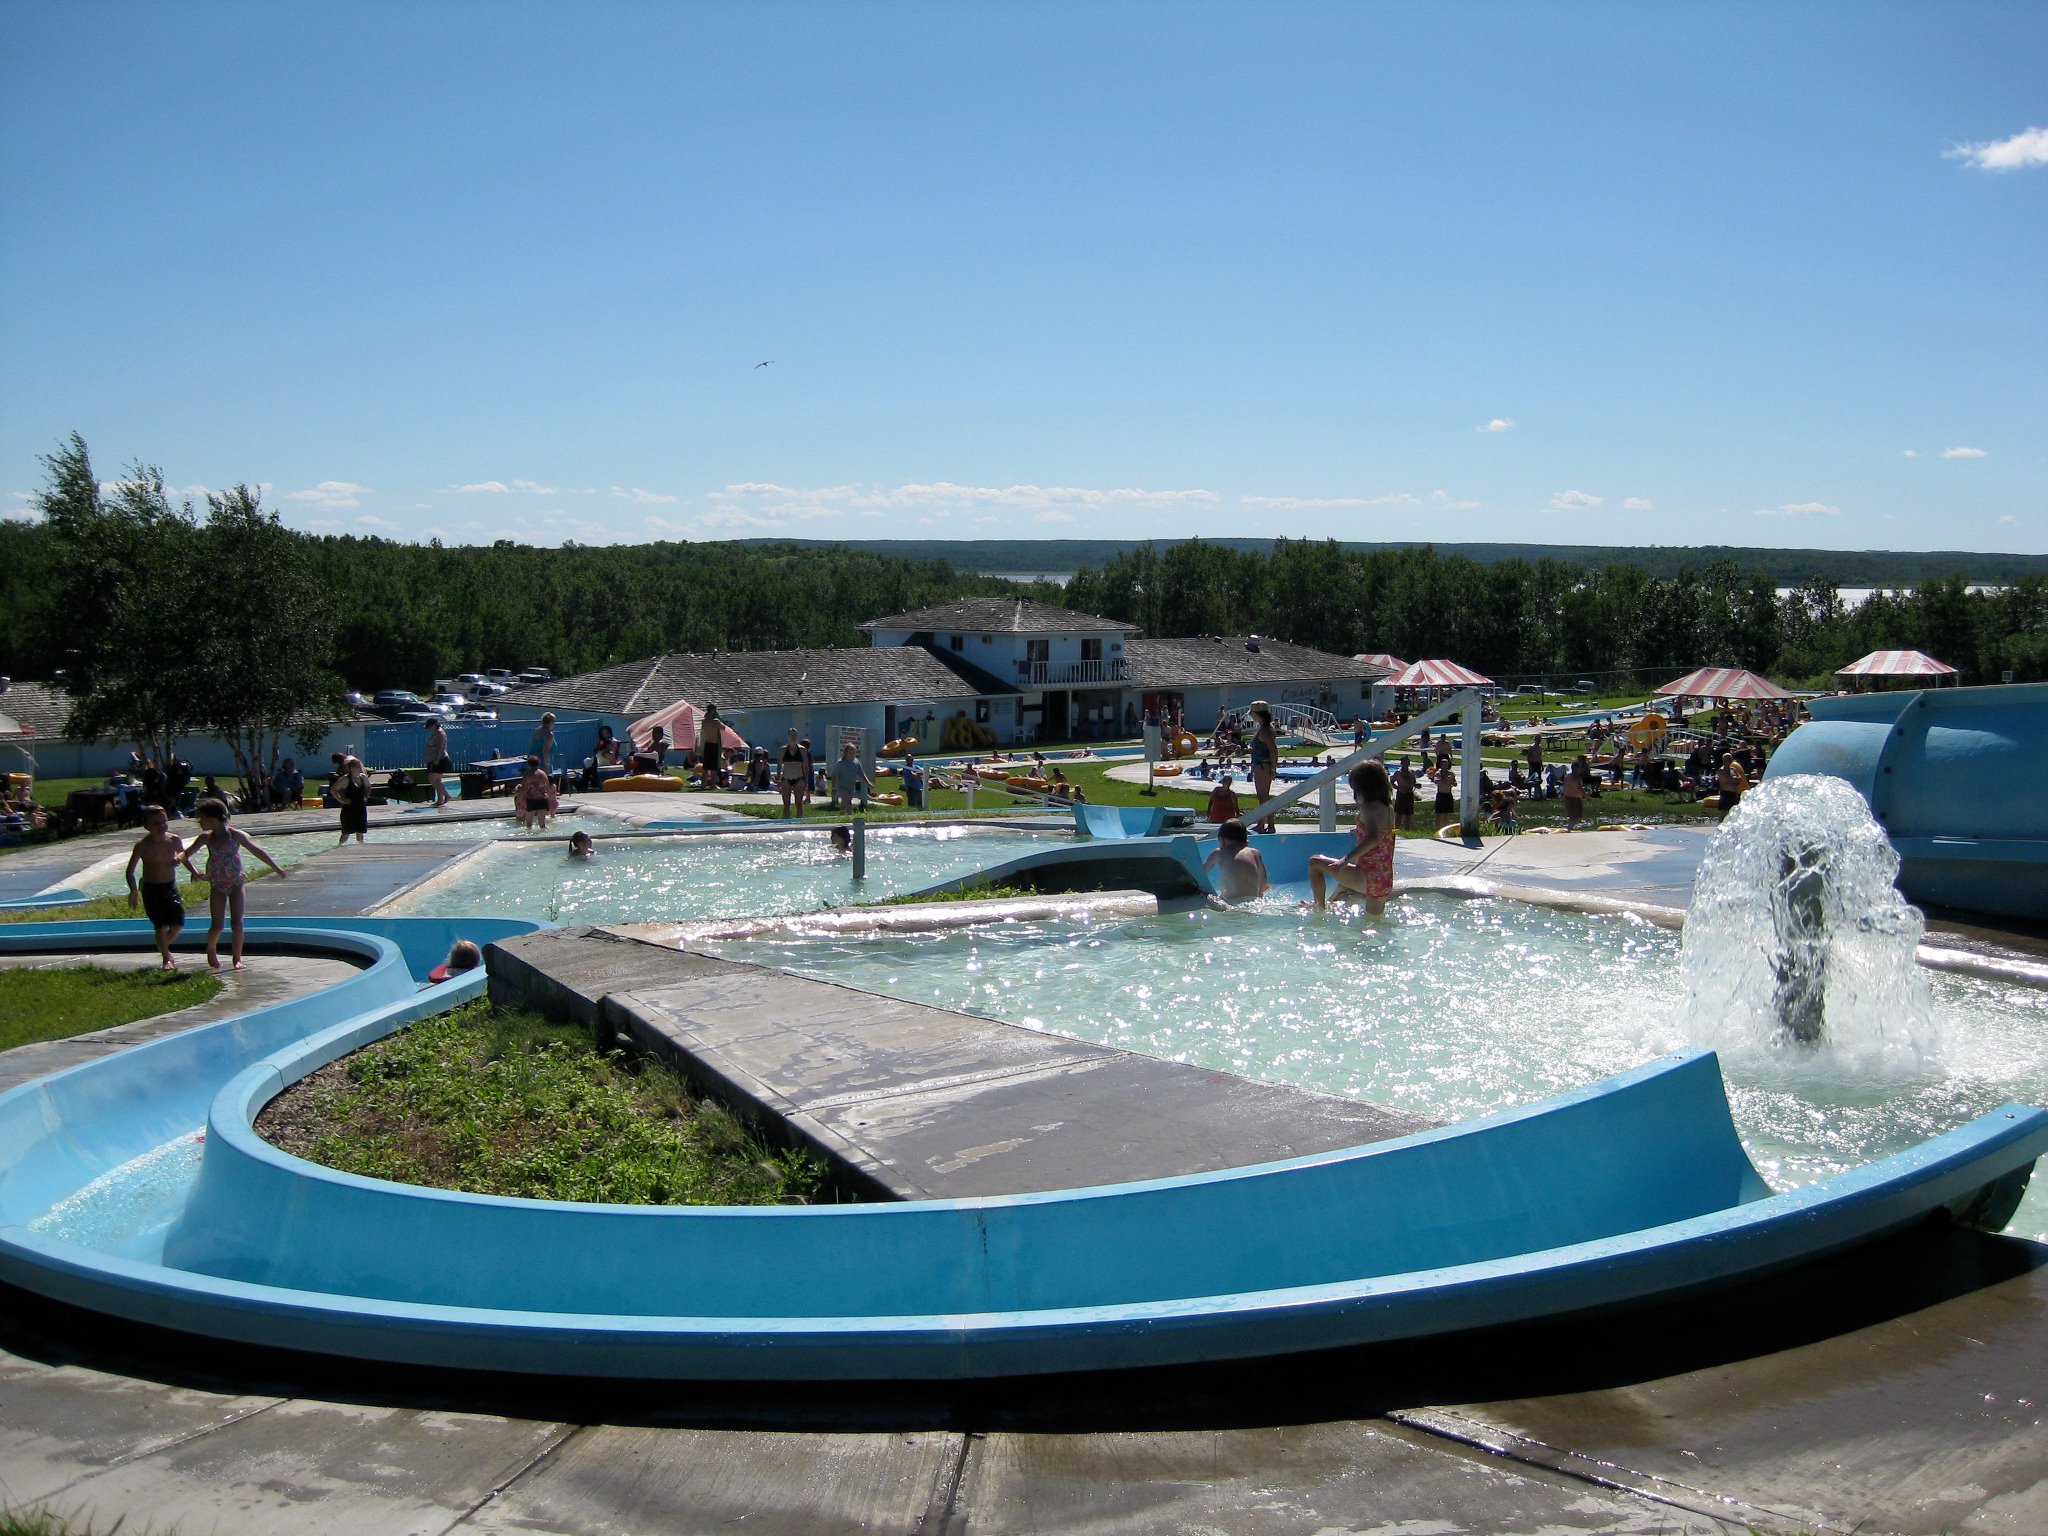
0,436,2048,764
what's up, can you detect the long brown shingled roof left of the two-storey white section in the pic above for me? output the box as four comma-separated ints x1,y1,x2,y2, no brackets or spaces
506,645,977,717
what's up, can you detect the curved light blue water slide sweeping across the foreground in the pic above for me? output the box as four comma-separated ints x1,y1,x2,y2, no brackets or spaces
0,920,2048,1380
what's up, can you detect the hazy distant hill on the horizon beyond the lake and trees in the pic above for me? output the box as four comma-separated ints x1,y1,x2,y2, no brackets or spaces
745,539,2048,588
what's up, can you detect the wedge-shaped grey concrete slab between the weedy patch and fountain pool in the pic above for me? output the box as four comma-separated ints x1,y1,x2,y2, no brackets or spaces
485,926,1430,1200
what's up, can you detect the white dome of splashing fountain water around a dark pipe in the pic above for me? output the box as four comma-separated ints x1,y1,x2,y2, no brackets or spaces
1679,774,1942,1077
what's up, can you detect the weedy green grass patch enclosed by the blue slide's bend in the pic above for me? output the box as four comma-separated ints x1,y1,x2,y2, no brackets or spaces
256,1001,823,1204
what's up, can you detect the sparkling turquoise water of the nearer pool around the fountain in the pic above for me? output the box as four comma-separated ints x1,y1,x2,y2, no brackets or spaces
723,893,2048,1241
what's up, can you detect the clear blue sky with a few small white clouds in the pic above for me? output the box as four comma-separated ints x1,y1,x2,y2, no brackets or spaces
0,0,2048,553
